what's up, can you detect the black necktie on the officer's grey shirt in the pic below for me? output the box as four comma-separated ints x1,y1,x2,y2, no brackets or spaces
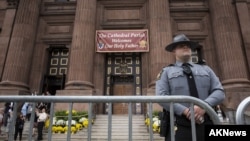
182,63,199,98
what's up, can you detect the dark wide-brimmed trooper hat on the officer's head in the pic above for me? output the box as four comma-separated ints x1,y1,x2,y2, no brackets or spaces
165,34,198,52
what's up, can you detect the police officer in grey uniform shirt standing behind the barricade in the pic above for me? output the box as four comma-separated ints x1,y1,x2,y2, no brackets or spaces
156,34,225,141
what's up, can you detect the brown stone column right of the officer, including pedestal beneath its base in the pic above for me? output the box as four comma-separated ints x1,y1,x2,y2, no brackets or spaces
209,0,250,120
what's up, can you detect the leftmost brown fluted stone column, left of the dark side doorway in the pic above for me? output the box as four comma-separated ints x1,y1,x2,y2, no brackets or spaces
0,0,40,94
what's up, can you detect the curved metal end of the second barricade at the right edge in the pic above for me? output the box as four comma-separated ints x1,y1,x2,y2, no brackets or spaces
235,96,250,124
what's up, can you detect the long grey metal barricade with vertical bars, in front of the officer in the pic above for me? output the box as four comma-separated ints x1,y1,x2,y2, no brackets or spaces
0,94,221,141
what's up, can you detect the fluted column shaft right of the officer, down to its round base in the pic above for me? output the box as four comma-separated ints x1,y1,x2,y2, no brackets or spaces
209,0,250,89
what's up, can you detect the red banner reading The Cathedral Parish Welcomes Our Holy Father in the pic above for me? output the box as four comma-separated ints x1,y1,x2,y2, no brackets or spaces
96,30,149,52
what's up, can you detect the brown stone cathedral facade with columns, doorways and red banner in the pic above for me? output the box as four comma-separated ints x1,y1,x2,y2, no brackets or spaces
0,0,250,118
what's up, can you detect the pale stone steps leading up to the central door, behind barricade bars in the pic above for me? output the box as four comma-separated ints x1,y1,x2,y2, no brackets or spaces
0,115,164,141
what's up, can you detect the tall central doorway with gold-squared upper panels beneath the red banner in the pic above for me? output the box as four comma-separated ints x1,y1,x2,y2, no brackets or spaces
103,53,142,114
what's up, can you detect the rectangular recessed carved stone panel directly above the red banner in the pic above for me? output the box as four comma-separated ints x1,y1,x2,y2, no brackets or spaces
98,0,147,29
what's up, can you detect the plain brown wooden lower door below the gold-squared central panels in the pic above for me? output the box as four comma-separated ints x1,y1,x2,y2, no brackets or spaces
113,83,134,114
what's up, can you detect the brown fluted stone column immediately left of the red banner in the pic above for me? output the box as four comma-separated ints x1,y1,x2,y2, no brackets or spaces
65,0,96,90
